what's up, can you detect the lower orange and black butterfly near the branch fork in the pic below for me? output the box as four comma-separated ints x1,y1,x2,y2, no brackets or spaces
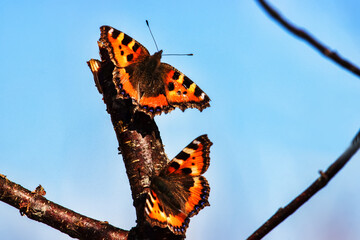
145,135,212,235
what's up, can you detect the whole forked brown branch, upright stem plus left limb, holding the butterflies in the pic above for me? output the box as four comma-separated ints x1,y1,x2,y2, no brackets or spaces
0,31,185,240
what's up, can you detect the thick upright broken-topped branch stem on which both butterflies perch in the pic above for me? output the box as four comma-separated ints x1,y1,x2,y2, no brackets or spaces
88,44,184,239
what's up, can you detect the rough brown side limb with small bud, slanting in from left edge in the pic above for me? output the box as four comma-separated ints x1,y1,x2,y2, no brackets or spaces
0,174,129,240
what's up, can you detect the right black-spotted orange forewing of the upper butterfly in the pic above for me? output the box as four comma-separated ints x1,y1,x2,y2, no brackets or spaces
160,63,210,111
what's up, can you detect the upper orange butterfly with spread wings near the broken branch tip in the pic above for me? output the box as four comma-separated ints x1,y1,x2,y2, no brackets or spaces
98,26,210,117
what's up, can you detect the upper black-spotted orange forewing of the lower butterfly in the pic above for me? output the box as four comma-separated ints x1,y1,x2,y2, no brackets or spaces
167,135,212,176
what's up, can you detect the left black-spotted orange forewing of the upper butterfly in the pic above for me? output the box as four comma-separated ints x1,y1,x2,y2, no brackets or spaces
100,26,149,67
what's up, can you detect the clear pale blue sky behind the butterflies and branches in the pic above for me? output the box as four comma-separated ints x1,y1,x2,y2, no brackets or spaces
0,0,360,240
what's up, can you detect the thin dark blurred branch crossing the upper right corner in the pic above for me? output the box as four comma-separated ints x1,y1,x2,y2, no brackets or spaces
257,0,360,77
